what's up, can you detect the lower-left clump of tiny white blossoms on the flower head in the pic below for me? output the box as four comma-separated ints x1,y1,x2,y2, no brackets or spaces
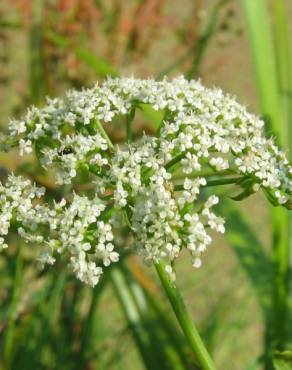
0,175,119,286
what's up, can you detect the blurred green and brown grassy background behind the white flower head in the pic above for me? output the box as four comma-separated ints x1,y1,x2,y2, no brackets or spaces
0,0,292,370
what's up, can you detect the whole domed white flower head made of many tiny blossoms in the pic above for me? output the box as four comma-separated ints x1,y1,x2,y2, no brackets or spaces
0,77,292,285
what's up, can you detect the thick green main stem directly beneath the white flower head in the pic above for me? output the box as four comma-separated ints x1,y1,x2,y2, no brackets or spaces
155,262,215,370
